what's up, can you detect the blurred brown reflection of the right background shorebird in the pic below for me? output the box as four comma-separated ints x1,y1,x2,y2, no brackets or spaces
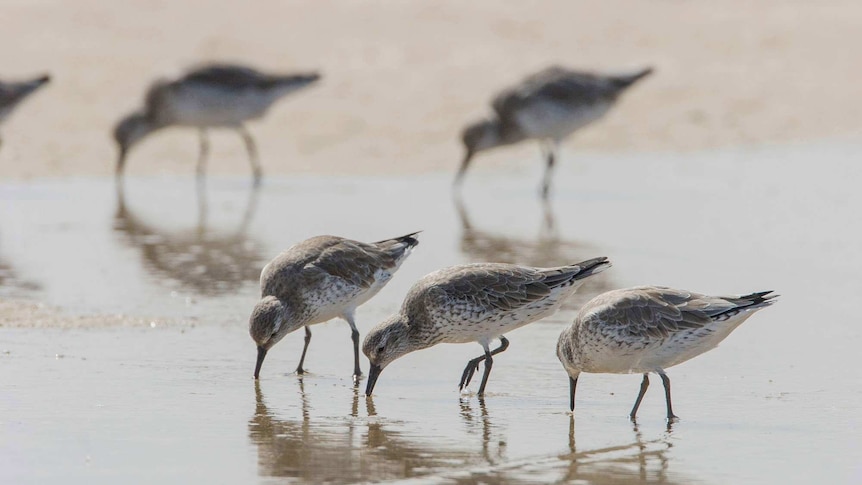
454,196,616,309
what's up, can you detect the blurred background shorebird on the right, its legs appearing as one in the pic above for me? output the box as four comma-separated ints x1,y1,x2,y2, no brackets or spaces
455,66,652,197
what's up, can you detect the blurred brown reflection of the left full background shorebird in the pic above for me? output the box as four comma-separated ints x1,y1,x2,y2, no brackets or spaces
114,184,265,296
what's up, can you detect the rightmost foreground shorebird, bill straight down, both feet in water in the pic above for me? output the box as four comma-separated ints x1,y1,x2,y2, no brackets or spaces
557,286,778,421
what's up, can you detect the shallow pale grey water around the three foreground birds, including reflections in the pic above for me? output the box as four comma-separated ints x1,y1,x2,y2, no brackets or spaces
0,143,862,484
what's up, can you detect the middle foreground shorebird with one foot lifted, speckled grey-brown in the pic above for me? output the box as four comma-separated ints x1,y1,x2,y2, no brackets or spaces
362,258,611,396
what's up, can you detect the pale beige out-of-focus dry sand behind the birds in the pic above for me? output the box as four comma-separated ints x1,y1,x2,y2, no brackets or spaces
0,0,862,179
